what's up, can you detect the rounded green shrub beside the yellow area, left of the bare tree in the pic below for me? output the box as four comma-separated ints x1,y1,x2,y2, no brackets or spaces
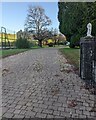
16,38,31,49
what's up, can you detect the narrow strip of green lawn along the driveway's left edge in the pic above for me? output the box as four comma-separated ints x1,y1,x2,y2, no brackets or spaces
0,49,28,58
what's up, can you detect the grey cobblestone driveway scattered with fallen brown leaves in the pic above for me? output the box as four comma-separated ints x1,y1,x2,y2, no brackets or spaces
2,48,96,118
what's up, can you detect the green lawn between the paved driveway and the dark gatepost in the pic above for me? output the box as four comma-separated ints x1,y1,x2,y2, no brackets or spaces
60,48,80,69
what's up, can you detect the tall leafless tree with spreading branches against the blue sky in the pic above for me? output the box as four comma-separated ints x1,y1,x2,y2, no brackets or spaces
25,6,51,47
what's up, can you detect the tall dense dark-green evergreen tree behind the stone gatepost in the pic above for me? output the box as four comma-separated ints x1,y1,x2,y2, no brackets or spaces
58,2,96,46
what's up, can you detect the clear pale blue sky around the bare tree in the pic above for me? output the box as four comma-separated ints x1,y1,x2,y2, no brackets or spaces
0,2,59,32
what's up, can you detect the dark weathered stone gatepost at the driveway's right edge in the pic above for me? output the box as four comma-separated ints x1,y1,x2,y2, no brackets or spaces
80,23,96,84
